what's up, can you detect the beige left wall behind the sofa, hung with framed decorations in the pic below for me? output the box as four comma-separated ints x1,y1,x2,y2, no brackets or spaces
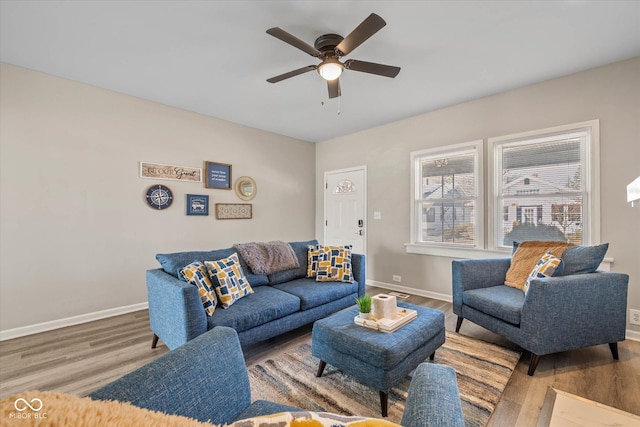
0,64,315,332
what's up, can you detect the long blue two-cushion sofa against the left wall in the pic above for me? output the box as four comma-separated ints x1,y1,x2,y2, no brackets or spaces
147,240,366,350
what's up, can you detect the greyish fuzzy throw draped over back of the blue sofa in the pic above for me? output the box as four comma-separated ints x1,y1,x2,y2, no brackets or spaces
233,240,300,274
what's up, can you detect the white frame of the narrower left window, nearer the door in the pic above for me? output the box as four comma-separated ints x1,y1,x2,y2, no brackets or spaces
406,140,484,255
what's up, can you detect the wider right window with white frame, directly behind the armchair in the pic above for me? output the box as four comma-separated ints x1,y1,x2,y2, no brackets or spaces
489,120,599,249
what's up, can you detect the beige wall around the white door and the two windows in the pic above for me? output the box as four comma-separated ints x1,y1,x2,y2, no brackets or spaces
316,58,640,338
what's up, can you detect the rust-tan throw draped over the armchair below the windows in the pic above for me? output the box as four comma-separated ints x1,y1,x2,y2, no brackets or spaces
504,240,573,290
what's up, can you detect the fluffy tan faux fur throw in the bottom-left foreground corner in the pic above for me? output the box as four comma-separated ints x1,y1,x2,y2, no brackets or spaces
0,391,212,427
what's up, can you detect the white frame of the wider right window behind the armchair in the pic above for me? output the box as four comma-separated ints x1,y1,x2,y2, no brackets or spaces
487,120,600,252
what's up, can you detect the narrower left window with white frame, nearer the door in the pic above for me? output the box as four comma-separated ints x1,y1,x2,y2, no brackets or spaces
411,141,482,248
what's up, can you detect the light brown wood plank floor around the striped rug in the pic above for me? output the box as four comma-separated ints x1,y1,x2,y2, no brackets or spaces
0,287,640,427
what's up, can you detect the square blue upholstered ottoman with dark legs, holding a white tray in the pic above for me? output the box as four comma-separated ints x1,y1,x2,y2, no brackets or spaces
311,302,445,417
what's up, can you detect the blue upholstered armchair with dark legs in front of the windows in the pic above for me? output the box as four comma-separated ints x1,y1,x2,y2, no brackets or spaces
452,258,629,375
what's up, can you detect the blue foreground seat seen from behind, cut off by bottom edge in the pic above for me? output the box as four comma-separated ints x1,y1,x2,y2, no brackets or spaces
89,327,464,427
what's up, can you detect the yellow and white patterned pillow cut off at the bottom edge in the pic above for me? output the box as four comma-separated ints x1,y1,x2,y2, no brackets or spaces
229,411,400,427
